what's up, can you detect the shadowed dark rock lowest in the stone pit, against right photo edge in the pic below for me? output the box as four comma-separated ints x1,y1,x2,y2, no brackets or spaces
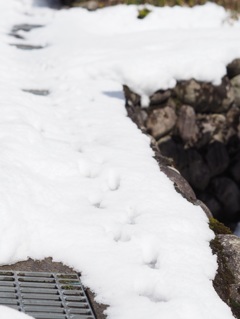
211,177,240,222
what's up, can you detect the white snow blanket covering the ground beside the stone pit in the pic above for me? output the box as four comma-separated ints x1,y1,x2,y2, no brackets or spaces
0,0,240,319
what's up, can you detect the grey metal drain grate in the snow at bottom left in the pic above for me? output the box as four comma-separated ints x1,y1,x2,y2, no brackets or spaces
0,271,95,319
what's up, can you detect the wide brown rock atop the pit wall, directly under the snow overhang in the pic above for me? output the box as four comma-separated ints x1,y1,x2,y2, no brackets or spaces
174,77,234,113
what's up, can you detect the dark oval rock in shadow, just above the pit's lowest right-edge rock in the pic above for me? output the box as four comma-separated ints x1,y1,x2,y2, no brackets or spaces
205,142,230,177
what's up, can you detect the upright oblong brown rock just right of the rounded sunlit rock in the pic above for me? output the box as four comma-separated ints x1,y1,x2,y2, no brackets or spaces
177,105,199,145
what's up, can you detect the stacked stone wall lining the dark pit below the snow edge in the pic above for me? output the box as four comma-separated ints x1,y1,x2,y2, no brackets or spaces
124,59,240,226
